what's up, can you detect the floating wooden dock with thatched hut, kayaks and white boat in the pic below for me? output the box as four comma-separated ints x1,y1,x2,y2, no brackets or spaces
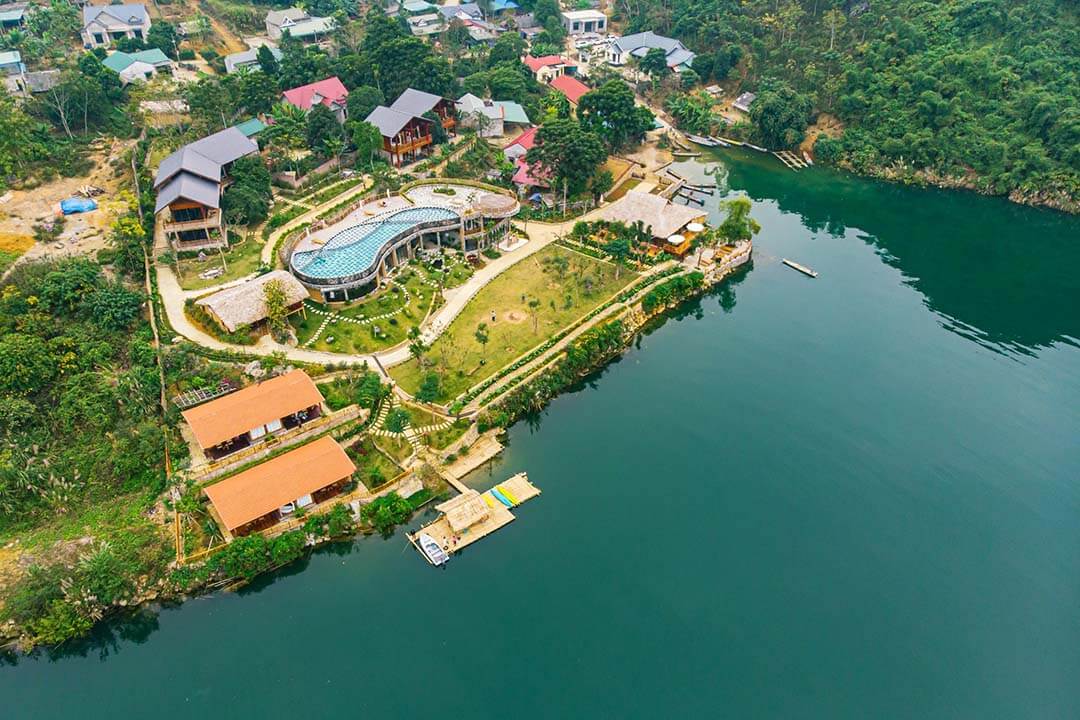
406,473,540,567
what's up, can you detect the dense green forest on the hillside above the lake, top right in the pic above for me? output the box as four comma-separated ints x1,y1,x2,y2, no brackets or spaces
620,0,1080,209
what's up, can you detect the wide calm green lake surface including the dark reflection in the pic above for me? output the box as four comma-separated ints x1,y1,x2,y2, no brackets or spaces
0,154,1080,720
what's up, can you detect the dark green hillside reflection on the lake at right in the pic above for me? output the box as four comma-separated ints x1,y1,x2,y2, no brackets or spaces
675,151,1080,353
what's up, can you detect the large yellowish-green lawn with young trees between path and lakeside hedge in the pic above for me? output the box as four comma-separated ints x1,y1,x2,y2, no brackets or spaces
390,246,637,403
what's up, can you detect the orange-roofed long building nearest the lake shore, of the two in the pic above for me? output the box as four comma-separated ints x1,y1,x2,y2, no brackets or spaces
203,435,356,536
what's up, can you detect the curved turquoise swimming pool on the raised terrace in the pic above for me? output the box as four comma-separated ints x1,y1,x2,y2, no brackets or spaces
289,207,460,282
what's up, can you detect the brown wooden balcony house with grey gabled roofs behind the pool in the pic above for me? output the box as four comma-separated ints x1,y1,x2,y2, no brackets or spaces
365,87,458,166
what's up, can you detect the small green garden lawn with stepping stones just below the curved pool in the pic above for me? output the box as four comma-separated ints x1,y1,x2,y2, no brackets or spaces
289,268,437,353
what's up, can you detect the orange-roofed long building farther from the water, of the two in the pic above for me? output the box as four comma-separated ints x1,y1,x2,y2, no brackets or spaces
181,370,323,460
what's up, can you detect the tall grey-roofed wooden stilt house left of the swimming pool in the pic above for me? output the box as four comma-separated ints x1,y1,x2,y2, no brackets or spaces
153,127,259,250
